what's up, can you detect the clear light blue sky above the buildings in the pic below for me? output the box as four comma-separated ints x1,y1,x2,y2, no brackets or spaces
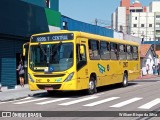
59,0,153,25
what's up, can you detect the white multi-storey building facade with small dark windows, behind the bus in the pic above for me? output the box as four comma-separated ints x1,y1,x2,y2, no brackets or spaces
129,12,154,41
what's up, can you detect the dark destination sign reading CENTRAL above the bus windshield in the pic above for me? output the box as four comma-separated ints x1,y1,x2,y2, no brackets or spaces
31,33,74,42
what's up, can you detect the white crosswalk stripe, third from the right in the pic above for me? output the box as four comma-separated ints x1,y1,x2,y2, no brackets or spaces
83,97,120,106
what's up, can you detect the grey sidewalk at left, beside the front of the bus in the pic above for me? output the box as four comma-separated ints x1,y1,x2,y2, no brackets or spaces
0,84,46,102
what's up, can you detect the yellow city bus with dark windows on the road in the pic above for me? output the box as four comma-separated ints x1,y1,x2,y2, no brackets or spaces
23,30,140,94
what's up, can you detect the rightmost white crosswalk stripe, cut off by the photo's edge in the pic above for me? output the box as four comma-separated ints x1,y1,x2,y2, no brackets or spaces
138,98,160,109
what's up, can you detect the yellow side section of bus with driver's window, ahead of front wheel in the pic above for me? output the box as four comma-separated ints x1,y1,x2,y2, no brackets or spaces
76,38,88,90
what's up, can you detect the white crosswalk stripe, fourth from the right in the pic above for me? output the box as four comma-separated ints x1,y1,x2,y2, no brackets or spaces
59,96,98,105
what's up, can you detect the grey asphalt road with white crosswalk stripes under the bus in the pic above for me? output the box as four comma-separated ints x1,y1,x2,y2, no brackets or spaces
0,78,160,120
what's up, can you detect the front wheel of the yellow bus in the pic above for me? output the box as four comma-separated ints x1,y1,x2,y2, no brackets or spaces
88,77,97,95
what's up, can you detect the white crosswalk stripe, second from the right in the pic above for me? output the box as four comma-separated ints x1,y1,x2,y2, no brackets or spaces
110,97,142,108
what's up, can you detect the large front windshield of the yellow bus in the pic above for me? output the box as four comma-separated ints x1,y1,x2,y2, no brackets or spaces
29,42,73,72
